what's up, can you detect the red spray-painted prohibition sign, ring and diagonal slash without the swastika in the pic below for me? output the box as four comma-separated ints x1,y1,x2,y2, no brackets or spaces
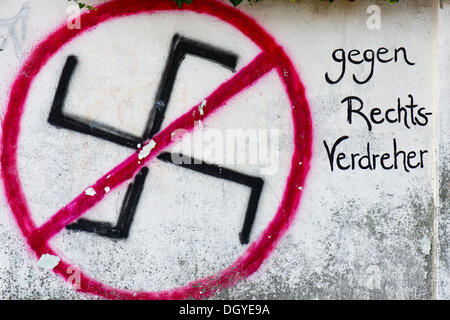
1,0,312,299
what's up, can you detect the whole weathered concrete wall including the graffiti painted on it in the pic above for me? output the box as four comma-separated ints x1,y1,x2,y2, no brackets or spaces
0,0,450,299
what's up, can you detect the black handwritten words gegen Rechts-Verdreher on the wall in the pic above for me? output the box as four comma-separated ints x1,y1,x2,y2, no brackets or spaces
323,47,433,172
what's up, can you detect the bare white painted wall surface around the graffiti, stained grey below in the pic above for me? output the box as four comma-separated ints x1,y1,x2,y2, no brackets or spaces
0,0,444,299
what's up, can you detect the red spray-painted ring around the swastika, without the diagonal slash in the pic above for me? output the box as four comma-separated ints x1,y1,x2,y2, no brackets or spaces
1,0,312,299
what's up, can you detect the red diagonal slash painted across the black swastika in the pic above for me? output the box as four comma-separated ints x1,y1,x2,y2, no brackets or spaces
31,48,279,246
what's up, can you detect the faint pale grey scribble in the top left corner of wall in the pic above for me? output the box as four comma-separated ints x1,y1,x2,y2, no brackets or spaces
0,2,30,58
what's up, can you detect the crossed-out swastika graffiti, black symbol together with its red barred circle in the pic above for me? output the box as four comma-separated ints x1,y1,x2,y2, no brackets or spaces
1,0,312,299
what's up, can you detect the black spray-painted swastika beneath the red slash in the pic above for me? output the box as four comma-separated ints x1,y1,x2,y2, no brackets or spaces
48,35,264,244
